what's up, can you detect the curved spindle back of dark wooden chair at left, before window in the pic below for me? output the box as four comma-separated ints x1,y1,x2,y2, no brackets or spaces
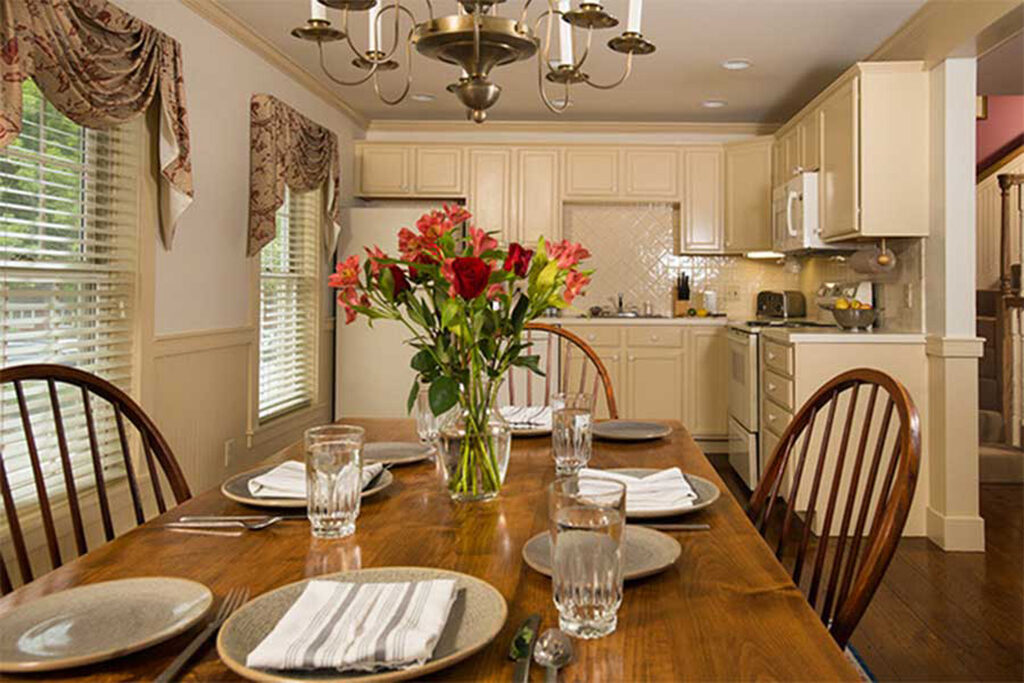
0,365,191,594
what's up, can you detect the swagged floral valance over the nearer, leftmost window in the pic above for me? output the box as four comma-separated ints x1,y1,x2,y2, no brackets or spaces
0,0,194,249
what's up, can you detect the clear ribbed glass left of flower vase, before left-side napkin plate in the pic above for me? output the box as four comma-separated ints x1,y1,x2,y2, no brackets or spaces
305,425,366,539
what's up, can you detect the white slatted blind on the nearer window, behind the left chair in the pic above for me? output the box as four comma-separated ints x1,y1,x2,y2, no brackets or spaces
0,80,138,503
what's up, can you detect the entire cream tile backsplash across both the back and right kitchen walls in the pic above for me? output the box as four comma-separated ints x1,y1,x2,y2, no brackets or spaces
563,203,924,332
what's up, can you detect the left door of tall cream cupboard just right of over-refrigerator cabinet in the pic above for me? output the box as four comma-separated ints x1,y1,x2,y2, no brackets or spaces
469,147,515,242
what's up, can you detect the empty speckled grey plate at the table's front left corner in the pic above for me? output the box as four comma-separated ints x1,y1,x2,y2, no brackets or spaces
0,577,213,673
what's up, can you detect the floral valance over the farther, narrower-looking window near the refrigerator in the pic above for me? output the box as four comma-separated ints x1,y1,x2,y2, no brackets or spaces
247,94,341,256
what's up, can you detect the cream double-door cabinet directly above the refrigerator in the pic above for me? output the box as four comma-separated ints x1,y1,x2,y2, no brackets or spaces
355,143,465,199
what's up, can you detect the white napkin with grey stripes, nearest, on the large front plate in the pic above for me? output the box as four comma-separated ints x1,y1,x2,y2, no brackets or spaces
246,579,456,672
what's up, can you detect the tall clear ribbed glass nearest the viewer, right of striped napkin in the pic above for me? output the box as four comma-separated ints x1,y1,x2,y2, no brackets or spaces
548,475,626,638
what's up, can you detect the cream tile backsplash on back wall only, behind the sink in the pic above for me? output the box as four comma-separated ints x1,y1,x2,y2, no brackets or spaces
563,204,801,319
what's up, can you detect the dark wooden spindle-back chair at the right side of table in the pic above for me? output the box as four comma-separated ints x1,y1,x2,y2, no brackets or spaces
748,369,921,647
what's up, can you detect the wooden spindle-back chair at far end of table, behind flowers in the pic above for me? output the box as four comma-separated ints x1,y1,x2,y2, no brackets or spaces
505,323,618,420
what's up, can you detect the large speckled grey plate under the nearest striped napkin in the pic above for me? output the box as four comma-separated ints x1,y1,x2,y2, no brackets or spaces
217,567,508,682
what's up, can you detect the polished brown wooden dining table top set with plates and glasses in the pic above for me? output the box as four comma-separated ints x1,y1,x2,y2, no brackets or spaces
0,419,858,681
